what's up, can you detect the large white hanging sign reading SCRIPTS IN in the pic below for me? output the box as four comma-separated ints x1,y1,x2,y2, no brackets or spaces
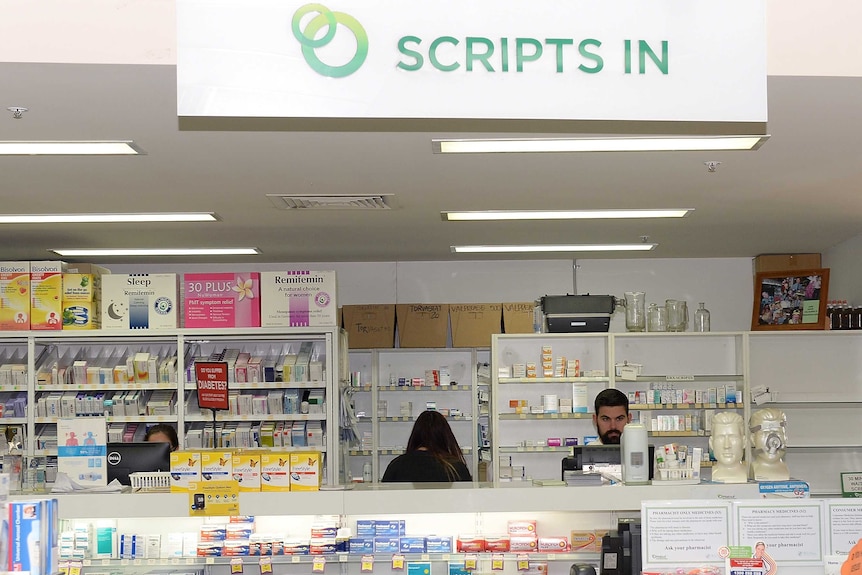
177,0,767,122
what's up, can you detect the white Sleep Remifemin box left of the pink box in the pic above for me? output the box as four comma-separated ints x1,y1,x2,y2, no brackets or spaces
102,274,179,329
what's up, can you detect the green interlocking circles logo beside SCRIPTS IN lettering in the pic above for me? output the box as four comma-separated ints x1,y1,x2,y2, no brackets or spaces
291,4,368,78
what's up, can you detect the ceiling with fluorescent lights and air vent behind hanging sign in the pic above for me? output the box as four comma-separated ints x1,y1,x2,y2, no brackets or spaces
0,58,862,263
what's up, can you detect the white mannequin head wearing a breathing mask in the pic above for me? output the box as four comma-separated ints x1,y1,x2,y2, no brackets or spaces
748,407,790,481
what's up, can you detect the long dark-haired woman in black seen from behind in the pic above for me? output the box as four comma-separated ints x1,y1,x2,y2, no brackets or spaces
383,411,473,483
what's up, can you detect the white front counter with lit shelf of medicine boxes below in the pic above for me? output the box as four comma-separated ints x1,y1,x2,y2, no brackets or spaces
49,483,757,575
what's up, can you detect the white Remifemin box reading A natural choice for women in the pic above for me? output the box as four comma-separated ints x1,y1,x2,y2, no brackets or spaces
260,270,338,327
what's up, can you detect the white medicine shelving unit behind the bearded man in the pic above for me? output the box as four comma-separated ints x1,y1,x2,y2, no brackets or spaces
491,332,747,484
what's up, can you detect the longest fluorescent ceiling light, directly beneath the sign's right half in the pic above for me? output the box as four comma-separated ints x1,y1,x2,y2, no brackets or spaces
431,135,769,154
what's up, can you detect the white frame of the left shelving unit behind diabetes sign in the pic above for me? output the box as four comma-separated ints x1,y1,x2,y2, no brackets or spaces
0,327,347,484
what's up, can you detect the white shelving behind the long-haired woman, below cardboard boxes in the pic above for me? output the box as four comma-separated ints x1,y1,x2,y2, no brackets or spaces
348,348,488,482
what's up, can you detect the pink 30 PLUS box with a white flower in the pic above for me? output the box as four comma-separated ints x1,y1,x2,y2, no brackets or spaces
183,272,260,328
